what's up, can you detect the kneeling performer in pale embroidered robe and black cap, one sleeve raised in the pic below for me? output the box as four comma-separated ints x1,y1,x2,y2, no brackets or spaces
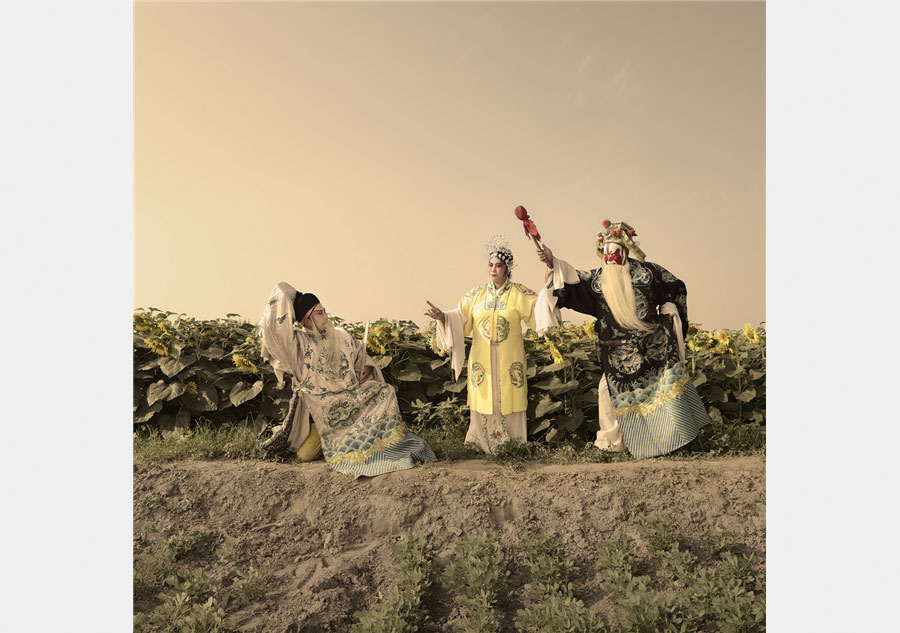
259,282,435,477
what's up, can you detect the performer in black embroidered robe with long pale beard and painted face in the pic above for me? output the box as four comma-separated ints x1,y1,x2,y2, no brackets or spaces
536,220,710,459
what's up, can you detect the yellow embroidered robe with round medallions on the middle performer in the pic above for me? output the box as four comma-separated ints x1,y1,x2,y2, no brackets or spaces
456,280,537,415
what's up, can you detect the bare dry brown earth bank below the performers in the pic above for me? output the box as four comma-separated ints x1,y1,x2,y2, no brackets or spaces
134,456,765,632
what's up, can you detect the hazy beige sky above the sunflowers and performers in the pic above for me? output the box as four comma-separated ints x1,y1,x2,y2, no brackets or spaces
134,2,765,328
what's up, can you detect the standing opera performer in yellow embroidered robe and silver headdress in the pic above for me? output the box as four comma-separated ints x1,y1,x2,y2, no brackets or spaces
425,236,537,453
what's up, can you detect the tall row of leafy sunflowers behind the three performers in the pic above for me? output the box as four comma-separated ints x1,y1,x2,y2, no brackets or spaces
134,308,766,446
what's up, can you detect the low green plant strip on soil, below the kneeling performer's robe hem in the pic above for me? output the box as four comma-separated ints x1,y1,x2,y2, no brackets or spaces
353,534,433,633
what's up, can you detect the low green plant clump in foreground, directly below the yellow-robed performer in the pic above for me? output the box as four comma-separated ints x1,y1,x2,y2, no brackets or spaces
442,535,509,633
